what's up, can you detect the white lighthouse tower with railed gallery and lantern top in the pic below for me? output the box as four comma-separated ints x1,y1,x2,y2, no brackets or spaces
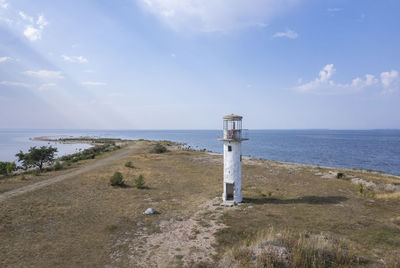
219,114,248,205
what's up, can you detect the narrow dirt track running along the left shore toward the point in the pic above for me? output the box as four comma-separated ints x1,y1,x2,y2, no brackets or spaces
0,145,134,203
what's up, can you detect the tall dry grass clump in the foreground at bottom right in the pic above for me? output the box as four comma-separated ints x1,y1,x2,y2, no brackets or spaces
222,228,368,267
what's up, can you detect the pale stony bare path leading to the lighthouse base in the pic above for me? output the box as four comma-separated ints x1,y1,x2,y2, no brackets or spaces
110,198,234,267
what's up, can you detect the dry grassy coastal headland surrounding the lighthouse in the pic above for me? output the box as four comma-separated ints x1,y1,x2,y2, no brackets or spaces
0,140,400,267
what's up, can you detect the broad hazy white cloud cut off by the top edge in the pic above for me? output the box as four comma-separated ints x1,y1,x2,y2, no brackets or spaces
137,0,301,32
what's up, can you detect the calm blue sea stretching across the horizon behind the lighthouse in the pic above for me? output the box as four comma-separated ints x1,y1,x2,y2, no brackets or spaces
0,129,400,176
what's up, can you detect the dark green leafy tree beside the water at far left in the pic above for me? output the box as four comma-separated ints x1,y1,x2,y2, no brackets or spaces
15,146,57,171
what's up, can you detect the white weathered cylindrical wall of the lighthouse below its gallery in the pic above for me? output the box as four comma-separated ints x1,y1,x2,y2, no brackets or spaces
222,141,242,203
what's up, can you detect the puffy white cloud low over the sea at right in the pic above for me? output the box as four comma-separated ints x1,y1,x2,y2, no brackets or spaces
295,64,379,94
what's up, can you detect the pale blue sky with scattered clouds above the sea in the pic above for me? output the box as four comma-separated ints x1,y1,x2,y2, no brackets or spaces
0,0,400,129
